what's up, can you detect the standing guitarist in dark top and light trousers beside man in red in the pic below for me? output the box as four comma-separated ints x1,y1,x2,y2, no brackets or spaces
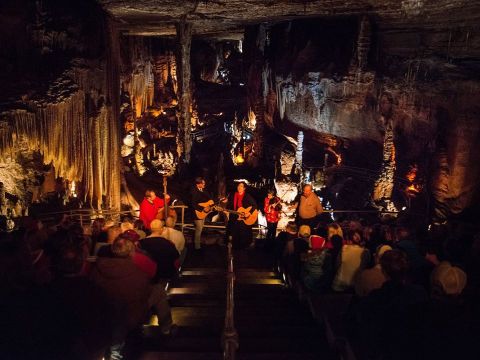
191,176,214,250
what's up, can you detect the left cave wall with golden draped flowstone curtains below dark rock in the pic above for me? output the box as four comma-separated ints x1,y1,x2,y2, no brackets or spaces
0,0,120,209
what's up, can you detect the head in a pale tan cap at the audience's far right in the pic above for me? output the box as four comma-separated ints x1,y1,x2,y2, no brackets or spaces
430,261,467,297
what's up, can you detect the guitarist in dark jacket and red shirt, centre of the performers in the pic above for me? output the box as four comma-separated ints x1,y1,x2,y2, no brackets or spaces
223,181,257,249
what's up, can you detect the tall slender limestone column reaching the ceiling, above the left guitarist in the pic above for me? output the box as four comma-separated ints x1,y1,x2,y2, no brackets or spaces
176,17,192,164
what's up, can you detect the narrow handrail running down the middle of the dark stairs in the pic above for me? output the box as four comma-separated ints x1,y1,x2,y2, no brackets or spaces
222,237,238,360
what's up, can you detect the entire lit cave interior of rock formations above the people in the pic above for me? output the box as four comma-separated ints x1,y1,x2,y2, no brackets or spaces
0,0,480,223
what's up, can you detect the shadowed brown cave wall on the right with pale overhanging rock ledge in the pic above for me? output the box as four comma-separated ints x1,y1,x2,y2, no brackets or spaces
245,17,480,219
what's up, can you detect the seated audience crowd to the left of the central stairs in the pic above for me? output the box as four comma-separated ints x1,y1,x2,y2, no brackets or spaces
0,217,186,360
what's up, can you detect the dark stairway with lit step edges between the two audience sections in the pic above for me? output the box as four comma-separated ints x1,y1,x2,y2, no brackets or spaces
130,246,333,360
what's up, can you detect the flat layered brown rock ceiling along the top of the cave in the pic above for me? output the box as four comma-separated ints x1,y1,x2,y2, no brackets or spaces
97,0,480,38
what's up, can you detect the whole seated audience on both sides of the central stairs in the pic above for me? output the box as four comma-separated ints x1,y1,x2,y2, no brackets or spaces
0,208,480,360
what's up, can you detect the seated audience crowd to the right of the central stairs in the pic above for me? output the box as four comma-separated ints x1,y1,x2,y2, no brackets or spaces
274,215,480,359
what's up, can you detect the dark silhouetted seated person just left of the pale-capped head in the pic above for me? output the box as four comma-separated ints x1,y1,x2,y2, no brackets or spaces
351,250,428,359
